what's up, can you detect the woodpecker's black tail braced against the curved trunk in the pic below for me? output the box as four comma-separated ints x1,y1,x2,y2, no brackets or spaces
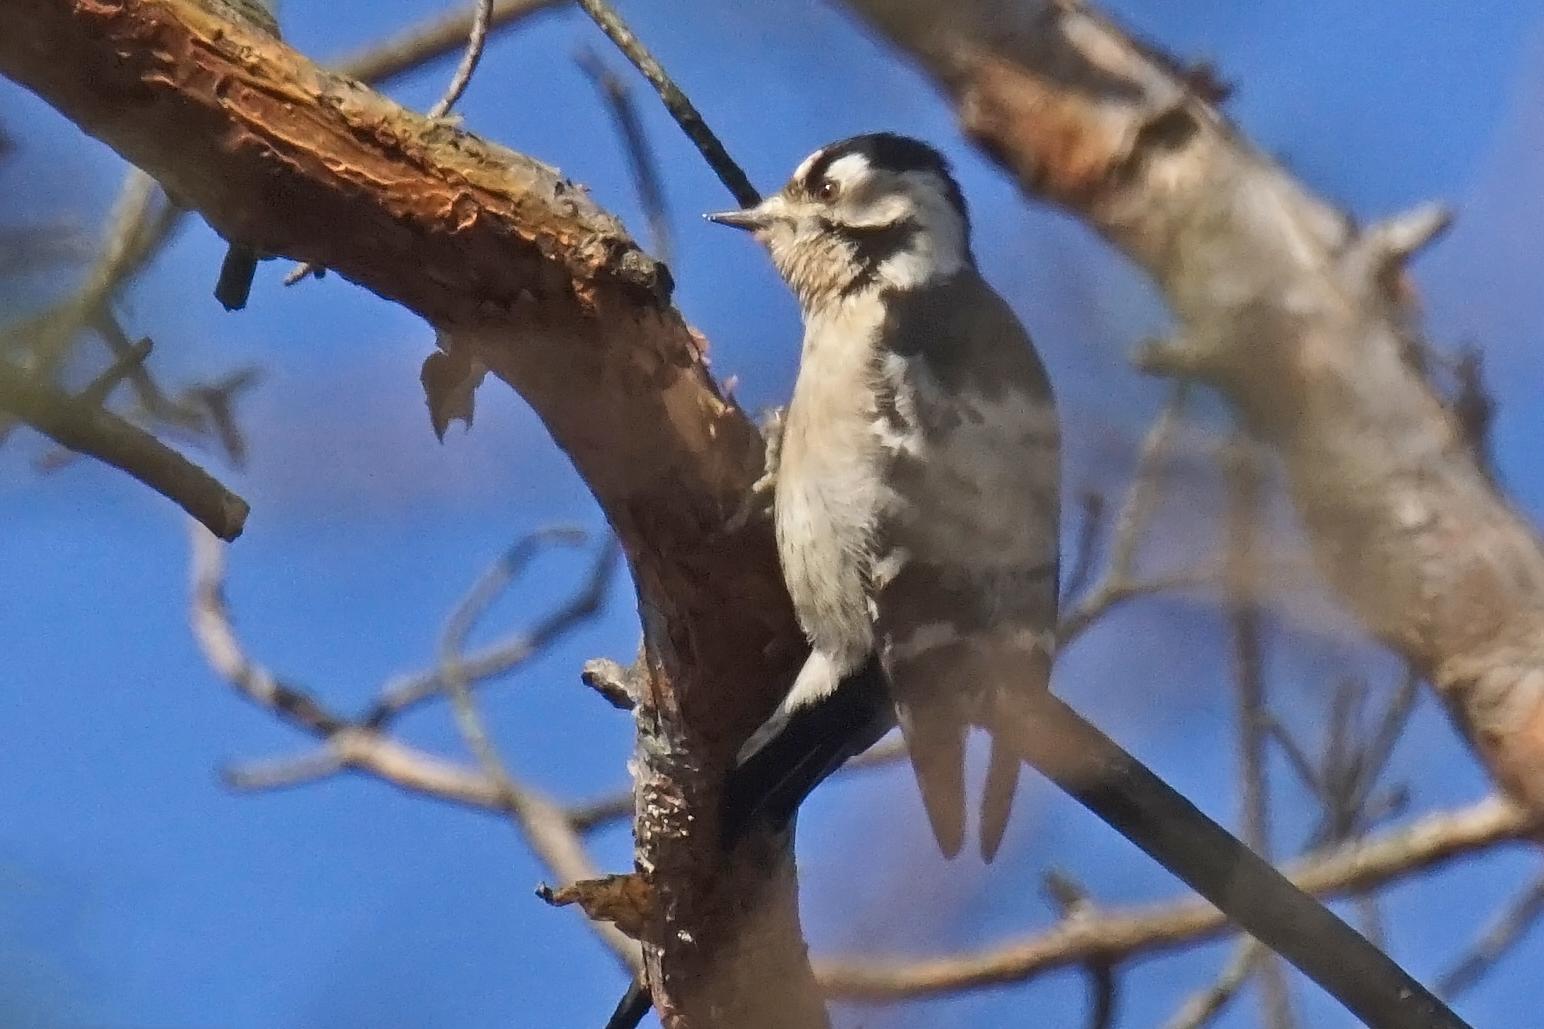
723,658,896,847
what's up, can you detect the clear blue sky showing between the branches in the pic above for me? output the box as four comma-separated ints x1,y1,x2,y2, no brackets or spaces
0,0,1544,1029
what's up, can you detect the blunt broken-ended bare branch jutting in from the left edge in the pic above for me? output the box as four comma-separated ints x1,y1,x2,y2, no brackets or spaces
0,363,249,539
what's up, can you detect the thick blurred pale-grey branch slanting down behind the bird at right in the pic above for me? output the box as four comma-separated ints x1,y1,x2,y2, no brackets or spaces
848,0,1544,810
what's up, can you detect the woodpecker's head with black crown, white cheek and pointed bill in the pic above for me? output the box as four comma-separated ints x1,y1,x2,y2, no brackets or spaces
709,133,971,312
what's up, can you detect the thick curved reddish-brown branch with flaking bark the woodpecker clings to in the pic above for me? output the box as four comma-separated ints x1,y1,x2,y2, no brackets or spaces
0,0,824,1029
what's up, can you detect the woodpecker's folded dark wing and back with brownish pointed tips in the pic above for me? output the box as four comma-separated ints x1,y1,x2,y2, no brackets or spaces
874,270,1061,861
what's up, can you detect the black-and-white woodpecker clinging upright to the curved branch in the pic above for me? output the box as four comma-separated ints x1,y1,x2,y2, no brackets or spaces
710,133,1061,861
